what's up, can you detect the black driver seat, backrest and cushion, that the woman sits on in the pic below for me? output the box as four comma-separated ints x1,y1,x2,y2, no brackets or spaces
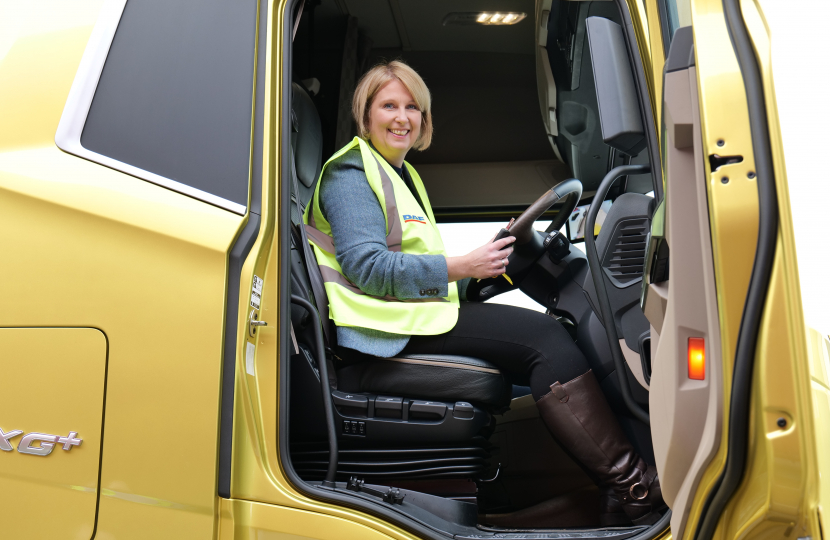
291,83,512,413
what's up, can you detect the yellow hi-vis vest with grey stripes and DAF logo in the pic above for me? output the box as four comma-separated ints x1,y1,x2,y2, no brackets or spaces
303,137,458,335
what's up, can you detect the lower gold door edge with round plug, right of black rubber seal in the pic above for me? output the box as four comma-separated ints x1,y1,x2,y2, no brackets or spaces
720,254,816,538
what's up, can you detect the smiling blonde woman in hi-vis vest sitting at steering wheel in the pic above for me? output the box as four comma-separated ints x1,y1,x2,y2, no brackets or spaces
305,61,663,523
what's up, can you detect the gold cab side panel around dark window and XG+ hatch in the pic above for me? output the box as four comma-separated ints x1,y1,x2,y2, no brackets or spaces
0,2,244,539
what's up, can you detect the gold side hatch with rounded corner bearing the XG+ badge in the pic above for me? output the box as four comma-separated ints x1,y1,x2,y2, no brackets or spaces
0,328,107,538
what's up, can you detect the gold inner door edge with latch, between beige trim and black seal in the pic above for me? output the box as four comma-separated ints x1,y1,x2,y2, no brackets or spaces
652,0,758,538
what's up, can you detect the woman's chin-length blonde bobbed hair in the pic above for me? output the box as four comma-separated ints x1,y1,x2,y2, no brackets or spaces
352,60,432,150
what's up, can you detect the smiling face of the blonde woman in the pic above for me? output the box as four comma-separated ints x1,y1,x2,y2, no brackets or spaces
369,79,421,167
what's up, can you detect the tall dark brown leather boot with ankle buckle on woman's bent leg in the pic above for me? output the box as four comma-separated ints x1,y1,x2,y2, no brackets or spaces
536,370,666,525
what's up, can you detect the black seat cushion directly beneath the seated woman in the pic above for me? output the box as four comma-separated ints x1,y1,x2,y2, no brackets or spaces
337,354,512,407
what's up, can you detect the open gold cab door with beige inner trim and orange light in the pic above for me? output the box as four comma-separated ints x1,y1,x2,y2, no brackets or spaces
642,0,827,540
